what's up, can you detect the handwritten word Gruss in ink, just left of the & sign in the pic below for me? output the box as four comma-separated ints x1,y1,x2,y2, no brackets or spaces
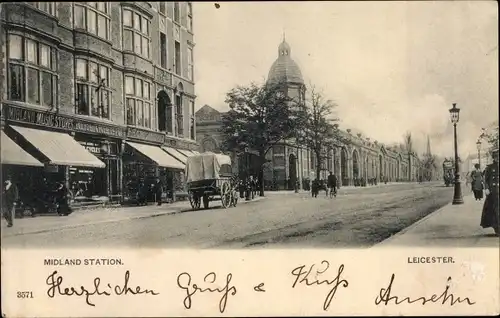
177,272,236,313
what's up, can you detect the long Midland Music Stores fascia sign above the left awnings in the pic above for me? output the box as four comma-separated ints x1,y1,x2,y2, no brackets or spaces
4,105,125,138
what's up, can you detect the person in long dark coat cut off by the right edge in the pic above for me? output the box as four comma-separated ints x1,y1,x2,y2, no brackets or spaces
481,145,500,235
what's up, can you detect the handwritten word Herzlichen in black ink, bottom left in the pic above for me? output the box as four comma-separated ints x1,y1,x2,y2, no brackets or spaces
45,271,159,307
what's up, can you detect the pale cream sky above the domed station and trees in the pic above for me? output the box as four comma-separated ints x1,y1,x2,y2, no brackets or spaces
193,1,499,156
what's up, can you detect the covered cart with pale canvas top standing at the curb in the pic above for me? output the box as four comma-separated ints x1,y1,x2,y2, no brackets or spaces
185,152,238,210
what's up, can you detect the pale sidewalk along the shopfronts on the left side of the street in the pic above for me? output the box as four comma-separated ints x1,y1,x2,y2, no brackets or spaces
1,197,265,237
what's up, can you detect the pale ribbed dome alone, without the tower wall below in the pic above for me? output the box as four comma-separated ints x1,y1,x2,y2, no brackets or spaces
267,40,304,84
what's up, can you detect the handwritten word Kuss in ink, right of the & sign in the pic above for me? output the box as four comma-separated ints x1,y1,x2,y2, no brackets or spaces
291,261,349,310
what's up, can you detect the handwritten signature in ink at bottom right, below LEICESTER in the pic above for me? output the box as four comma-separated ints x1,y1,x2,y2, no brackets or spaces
375,274,475,306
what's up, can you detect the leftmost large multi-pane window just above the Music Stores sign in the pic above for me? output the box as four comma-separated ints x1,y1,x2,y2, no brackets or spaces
8,34,57,107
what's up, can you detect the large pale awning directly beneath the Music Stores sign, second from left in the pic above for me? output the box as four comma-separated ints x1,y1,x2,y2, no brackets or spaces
11,126,106,168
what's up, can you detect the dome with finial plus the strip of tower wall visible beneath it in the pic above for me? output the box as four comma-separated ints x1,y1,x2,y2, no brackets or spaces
267,36,305,101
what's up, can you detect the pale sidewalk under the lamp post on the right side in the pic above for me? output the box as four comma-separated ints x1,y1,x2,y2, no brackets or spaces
374,194,500,248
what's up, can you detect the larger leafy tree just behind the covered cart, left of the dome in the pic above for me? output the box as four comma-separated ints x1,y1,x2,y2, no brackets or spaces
222,83,297,196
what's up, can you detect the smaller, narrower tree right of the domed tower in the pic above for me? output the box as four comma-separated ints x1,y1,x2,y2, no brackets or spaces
296,86,343,180
